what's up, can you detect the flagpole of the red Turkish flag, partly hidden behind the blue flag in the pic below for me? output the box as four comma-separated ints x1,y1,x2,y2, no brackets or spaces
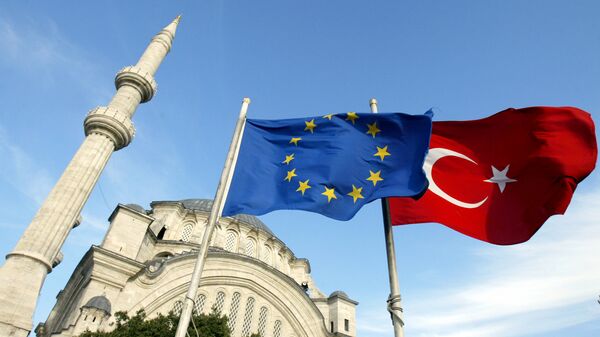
369,98,404,337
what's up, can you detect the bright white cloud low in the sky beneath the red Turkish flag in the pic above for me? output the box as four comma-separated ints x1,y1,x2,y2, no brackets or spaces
405,186,600,337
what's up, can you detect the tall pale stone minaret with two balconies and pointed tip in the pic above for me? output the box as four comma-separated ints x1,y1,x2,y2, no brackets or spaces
0,16,180,337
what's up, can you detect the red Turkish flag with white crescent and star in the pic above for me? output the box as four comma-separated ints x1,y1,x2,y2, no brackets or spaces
388,107,597,245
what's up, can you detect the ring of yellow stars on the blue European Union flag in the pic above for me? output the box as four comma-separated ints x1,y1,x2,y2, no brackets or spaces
281,112,392,203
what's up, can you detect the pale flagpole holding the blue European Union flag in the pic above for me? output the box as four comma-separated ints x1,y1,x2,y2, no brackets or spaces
175,98,250,337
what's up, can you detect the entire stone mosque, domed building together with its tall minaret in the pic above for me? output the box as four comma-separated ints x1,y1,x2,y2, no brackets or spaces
0,17,358,337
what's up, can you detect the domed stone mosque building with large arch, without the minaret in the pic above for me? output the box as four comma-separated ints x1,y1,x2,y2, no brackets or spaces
36,199,358,337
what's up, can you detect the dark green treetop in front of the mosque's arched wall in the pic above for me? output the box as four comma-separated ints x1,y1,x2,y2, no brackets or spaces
79,309,231,337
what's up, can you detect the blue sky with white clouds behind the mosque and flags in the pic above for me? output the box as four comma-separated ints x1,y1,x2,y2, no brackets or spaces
0,0,600,337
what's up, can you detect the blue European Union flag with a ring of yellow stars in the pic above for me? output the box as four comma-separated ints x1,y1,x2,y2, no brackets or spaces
223,112,432,220
